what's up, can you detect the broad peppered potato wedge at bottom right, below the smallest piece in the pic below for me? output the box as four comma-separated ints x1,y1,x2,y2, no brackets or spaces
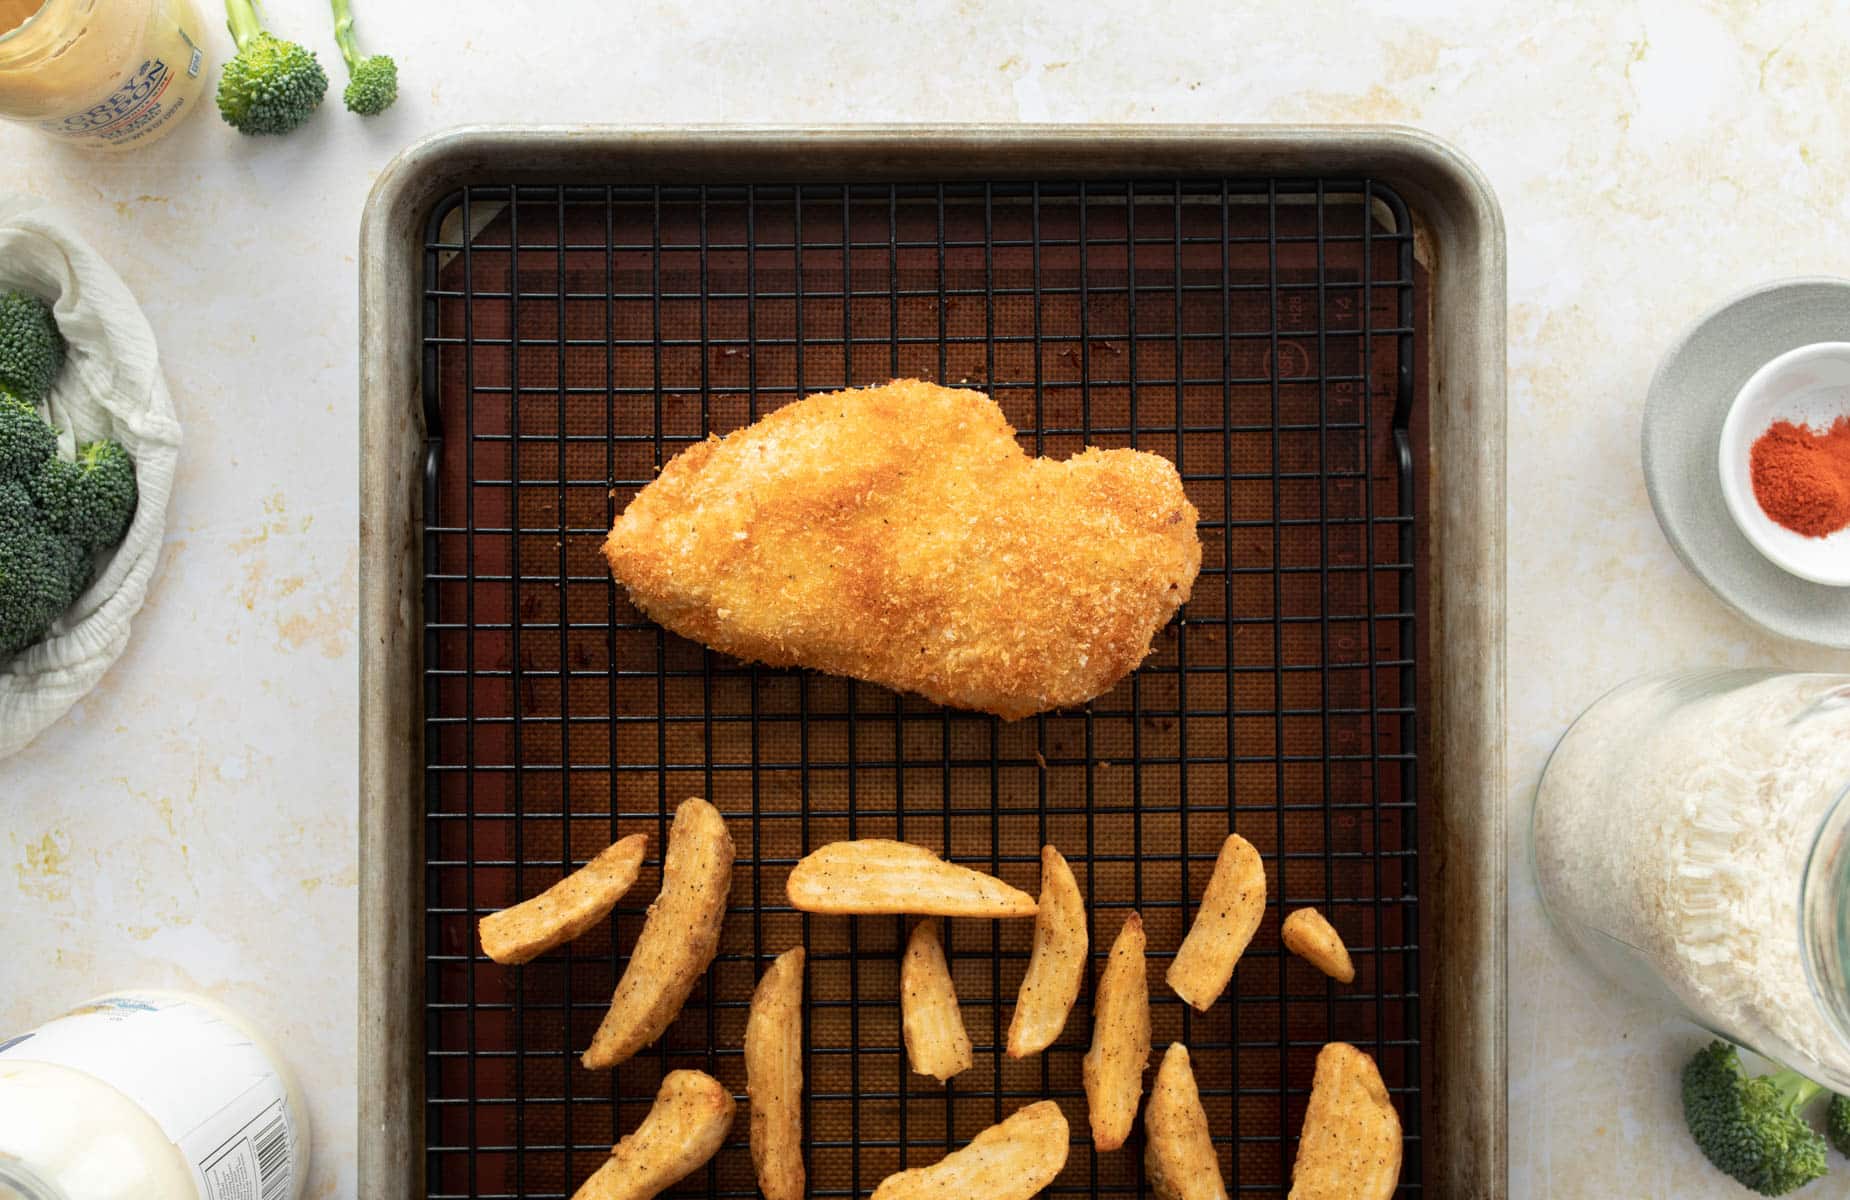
1289,1041,1400,1200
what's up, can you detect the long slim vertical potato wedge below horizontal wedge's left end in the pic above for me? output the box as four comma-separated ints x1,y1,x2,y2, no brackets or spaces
746,947,803,1200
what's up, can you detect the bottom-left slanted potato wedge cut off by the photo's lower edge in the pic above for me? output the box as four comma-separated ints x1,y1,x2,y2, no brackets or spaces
572,1071,734,1200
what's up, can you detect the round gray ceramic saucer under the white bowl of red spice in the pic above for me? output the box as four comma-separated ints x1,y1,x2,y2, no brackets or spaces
1645,277,1850,649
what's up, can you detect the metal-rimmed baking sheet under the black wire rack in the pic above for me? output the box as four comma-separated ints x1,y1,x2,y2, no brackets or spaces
363,129,1502,1194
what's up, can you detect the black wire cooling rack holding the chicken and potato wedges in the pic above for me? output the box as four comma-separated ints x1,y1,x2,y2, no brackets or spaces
422,178,1425,1200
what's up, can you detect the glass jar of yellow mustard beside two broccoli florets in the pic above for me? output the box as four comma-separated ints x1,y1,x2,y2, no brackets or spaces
0,0,207,150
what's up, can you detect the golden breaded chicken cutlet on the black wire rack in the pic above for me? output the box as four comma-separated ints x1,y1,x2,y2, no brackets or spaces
603,379,1201,719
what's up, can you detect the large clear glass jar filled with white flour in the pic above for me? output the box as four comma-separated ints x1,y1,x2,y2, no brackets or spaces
1534,671,1850,1093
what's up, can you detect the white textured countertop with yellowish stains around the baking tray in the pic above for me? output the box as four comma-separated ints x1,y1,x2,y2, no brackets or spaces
0,0,1850,1200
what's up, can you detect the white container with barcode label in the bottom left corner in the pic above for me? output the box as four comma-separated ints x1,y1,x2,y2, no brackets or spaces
0,991,309,1200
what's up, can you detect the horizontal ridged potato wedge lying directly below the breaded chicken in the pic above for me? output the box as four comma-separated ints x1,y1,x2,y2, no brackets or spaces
784,838,1038,917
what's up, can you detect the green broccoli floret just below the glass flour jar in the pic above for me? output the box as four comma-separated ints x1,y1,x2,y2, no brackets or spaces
1684,1041,1828,1196
